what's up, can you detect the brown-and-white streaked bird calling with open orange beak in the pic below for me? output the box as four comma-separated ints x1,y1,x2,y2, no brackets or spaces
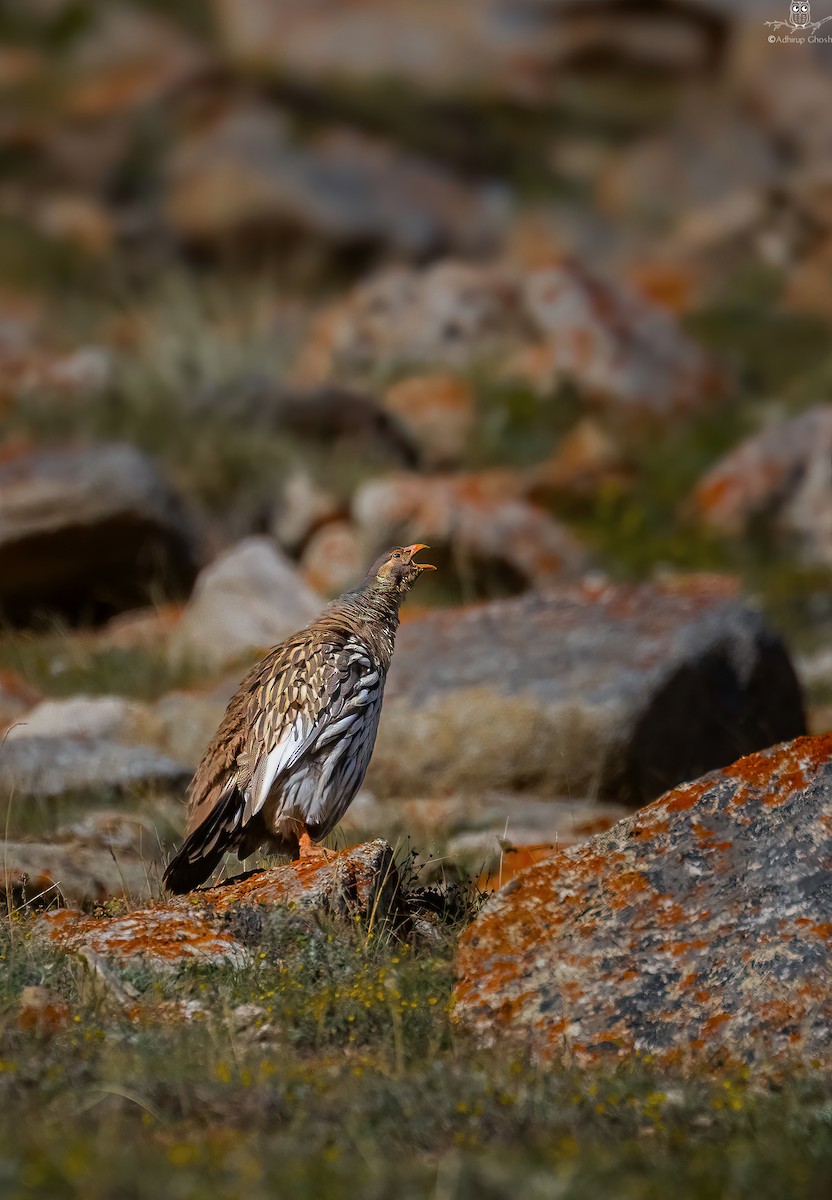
162,542,436,893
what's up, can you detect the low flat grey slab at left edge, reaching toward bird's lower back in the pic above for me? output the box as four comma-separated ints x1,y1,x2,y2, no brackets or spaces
0,734,190,804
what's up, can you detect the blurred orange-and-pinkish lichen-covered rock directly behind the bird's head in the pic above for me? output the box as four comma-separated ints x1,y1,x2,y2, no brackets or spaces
353,470,587,592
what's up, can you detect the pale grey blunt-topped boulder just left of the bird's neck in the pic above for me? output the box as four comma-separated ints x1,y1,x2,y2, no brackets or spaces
170,538,321,667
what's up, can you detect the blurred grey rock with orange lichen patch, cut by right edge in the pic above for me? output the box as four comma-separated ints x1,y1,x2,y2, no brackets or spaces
692,404,832,565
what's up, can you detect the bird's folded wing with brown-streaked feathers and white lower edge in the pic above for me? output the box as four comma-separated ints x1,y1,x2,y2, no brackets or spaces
243,638,379,824
